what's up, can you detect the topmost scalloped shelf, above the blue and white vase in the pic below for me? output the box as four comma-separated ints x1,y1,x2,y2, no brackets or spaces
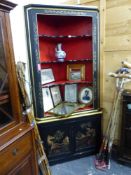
38,34,92,39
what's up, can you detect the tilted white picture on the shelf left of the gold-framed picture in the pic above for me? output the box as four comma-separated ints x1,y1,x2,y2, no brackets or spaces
41,68,55,84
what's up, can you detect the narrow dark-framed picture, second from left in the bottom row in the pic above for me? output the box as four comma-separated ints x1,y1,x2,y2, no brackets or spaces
50,86,62,106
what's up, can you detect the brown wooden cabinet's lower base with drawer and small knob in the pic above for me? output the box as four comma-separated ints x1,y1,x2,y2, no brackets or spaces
0,123,37,175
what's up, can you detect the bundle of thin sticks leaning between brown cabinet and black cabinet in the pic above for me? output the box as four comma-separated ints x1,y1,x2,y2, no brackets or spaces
17,62,51,175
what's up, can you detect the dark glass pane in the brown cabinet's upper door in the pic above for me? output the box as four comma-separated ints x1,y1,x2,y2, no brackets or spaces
0,20,13,128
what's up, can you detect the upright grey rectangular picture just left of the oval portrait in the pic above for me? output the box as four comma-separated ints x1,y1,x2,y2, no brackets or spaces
65,84,77,102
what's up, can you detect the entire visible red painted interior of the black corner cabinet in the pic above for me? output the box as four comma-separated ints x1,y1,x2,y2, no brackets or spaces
37,15,93,109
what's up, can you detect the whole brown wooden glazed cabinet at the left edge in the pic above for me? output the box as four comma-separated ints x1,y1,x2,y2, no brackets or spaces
0,0,38,175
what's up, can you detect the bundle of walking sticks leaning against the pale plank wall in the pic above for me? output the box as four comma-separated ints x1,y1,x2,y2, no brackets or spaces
95,68,131,170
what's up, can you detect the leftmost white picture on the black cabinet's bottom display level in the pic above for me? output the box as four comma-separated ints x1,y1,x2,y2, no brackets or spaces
42,88,54,112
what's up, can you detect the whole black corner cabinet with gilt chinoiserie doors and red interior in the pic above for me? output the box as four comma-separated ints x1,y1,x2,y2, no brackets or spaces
25,4,102,164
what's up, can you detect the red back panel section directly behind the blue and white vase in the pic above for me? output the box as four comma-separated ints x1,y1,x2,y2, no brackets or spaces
39,38,92,62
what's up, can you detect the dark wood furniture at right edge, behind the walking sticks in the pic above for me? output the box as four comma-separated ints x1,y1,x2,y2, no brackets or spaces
118,90,131,165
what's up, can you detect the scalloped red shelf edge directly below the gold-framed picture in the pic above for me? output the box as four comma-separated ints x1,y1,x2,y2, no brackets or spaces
42,80,93,88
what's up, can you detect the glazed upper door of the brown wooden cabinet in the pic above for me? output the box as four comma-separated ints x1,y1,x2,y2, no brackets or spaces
0,5,21,133
